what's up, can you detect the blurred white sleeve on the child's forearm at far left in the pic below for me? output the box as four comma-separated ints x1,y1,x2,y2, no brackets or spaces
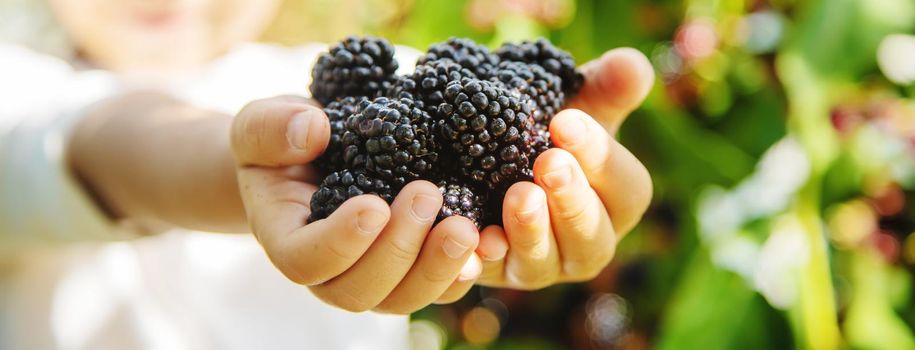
0,44,136,255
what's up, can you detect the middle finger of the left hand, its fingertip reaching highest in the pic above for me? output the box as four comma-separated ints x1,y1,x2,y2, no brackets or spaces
311,181,442,311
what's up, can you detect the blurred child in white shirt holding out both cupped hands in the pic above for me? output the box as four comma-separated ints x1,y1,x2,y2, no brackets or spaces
0,0,653,349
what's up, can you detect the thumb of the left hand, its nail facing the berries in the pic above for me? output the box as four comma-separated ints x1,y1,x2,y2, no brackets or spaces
231,96,330,166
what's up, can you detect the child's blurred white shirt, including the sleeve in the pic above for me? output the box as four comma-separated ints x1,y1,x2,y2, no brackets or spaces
0,44,416,349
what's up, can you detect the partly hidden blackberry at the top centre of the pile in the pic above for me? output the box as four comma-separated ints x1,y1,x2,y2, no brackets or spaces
416,38,499,77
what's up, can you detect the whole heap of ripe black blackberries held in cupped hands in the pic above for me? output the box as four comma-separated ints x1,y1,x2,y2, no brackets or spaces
308,37,584,227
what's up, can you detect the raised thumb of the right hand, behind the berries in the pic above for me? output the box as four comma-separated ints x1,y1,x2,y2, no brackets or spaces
569,48,655,134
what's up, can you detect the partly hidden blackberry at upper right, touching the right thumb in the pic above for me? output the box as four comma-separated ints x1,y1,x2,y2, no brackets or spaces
496,38,585,97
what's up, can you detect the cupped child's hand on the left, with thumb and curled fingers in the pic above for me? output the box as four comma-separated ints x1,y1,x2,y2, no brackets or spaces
231,96,481,314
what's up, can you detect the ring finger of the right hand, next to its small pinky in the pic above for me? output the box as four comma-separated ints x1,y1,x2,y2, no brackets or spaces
502,182,560,289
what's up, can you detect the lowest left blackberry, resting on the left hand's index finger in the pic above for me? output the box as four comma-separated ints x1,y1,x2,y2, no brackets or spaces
308,170,396,223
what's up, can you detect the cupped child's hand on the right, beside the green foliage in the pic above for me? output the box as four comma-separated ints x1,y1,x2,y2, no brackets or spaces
477,49,654,289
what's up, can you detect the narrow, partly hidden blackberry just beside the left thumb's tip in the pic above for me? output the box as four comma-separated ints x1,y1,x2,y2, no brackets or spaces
314,97,366,173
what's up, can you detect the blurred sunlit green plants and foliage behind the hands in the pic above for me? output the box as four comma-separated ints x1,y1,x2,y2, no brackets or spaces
7,0,915,349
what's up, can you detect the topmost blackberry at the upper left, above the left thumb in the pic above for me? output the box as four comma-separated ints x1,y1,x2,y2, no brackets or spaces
310,36,397,105
